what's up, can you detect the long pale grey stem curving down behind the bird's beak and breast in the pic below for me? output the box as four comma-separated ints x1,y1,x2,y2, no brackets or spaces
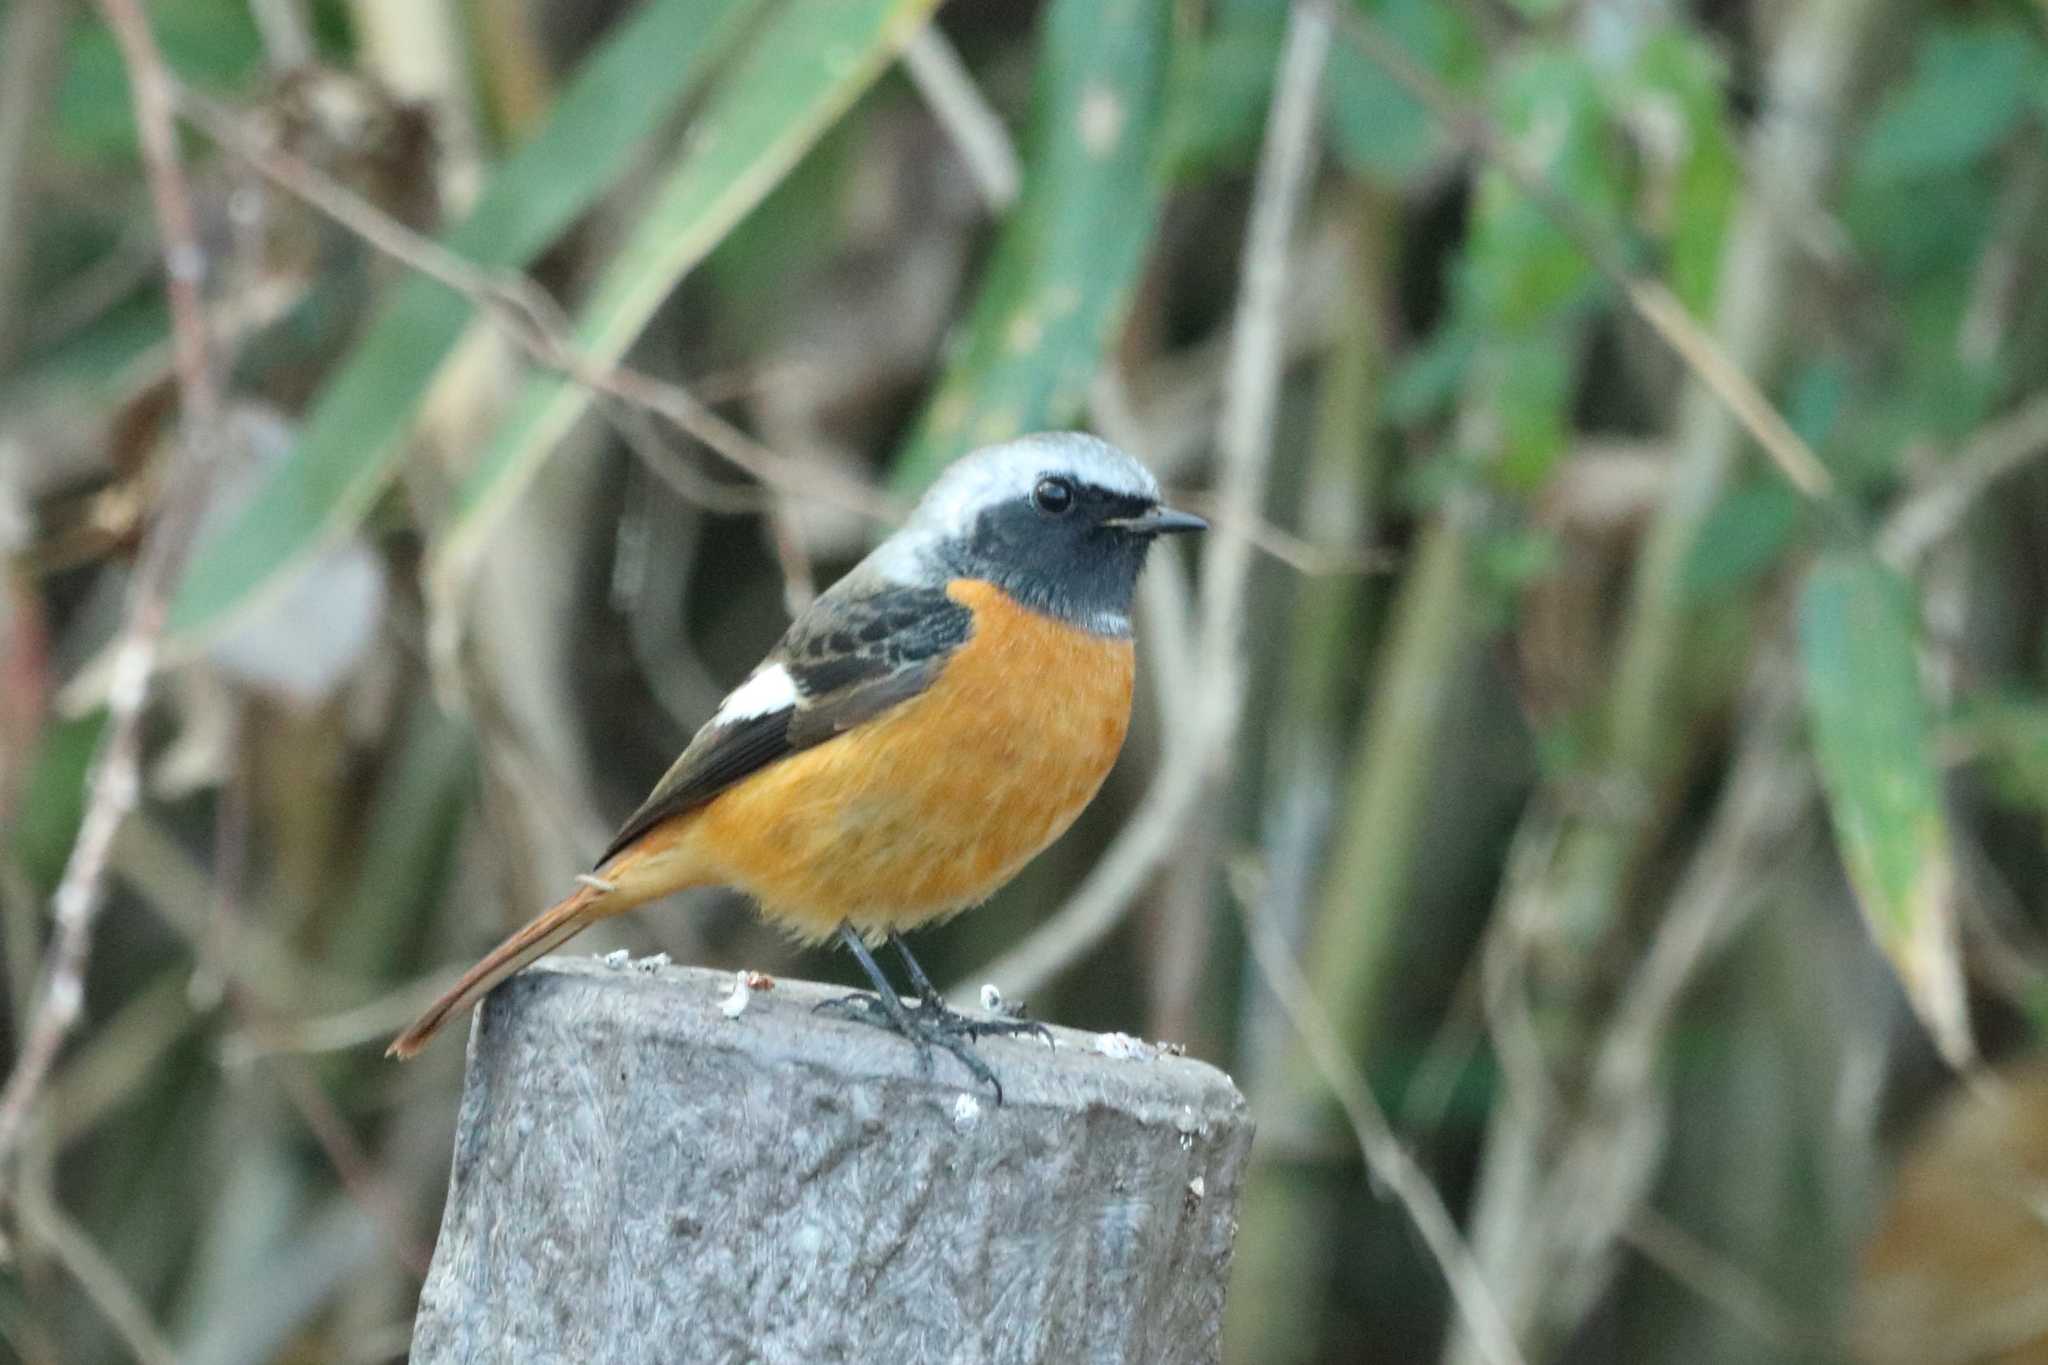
954,0,1331,995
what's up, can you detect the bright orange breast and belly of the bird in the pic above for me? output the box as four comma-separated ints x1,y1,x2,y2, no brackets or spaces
678,579,1133,939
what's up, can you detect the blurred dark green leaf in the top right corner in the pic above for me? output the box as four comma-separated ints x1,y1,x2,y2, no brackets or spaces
1858,25,2042,184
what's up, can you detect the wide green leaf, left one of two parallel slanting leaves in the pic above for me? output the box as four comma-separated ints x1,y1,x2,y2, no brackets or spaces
170,0,758,634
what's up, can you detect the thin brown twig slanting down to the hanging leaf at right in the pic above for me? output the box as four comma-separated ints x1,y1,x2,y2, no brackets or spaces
1337,4,1835,499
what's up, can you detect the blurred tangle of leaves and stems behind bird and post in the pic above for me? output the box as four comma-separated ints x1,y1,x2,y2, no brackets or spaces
0,0,2048,1365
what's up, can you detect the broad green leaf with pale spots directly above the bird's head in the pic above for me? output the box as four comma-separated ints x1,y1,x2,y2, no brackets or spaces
893,0,1174,489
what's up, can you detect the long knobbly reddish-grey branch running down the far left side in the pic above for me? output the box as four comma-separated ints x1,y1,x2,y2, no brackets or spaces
0,0,223,1171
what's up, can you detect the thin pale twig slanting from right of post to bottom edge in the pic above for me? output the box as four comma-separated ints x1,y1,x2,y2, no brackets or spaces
1231,862,1522,1365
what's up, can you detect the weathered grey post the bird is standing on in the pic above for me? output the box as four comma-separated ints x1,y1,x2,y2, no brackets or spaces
412,958,1251,1365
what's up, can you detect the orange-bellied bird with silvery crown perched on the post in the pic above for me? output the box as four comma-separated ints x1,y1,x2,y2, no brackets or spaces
389,432,1206,1103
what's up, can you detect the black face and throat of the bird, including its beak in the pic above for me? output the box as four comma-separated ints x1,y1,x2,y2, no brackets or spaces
948,475,1198,634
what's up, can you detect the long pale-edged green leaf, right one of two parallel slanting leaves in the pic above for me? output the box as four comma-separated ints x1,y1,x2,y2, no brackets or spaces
430,0,938,591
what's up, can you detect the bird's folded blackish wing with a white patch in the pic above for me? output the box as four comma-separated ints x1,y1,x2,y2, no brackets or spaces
598,581,975,868
